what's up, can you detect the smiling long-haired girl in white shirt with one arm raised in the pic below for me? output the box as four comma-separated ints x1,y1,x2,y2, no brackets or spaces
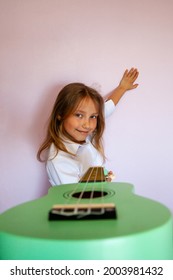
37,68,139,186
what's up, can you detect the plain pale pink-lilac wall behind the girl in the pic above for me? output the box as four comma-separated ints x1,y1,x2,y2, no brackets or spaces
0,0,173,212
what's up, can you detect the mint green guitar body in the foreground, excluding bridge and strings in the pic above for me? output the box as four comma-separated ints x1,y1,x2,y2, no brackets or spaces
0,182,172,260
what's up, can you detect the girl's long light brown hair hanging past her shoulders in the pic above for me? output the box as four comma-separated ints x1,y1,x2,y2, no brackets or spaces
37,83,105,161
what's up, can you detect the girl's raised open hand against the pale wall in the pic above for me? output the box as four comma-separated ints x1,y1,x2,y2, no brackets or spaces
118,68,139,91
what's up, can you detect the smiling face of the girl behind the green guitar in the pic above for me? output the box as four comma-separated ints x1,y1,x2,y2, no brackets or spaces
63,98,98,142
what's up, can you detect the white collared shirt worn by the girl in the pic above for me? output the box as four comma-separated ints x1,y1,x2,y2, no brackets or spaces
46,100,115,186
